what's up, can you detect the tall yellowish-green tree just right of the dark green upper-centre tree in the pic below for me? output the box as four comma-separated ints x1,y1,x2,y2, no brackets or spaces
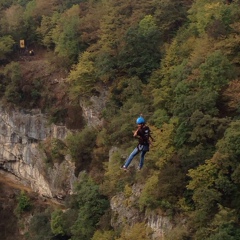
150,36,192,112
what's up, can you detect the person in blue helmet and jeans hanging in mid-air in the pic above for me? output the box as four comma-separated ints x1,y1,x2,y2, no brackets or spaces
121,116,153,170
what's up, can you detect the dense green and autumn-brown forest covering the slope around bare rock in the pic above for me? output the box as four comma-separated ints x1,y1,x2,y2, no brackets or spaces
0,0,240,240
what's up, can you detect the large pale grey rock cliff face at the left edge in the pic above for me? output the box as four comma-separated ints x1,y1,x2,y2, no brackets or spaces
0,107,75,198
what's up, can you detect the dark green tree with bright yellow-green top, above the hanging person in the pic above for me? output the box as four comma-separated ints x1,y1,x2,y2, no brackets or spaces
119,15,160,82
